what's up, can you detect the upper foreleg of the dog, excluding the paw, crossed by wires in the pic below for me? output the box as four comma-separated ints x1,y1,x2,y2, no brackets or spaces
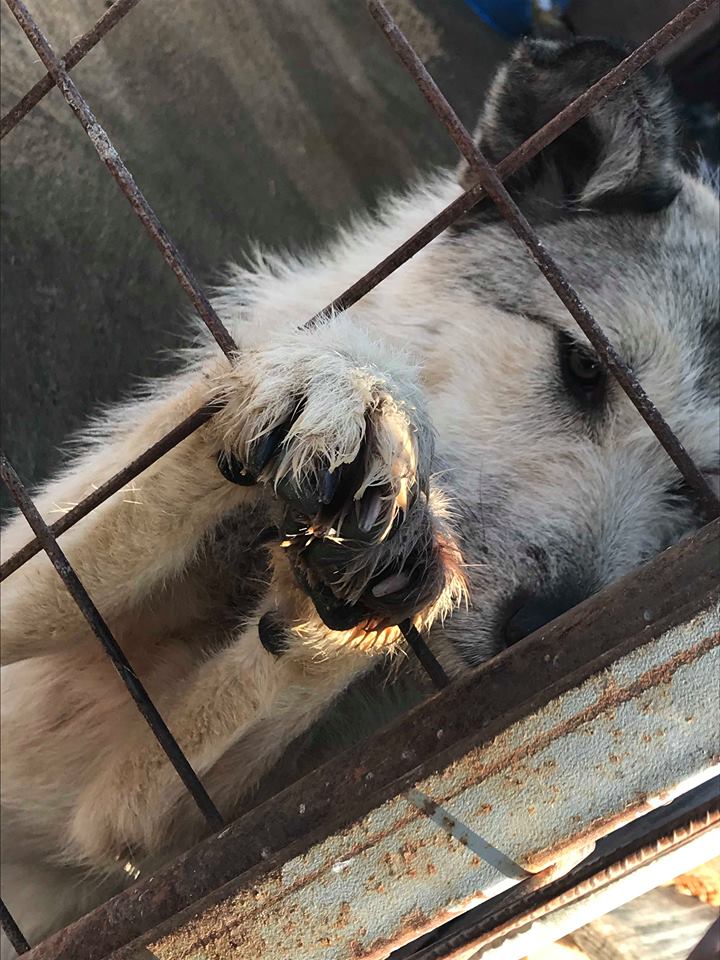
2,361,259,663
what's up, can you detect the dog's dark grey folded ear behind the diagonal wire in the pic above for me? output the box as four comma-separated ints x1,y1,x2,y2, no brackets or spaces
460,39,680,216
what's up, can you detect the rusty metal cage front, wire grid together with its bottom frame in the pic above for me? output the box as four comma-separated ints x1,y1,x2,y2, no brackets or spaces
0,0,720,960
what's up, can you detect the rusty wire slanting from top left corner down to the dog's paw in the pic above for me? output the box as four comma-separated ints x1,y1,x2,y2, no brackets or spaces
5,0,237,358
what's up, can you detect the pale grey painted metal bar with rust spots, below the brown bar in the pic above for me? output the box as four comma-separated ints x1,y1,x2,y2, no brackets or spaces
115,603,720,960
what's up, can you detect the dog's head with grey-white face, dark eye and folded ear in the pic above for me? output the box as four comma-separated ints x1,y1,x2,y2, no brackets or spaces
440,40,720,661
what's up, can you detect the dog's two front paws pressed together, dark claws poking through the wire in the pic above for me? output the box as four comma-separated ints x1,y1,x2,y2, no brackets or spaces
211,325,464,632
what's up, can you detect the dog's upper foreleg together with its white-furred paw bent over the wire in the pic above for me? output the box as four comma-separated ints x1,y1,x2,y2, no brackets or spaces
2,318,462,663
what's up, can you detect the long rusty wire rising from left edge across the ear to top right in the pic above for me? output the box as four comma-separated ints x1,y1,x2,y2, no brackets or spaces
0,0,717,580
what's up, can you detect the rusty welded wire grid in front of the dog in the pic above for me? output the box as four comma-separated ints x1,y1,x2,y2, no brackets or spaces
0,0,720,953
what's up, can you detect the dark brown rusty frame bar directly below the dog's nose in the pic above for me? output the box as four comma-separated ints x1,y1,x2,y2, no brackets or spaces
19,520,720,960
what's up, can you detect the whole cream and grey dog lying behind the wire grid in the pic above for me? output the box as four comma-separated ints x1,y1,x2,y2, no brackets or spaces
2,40,720,957
